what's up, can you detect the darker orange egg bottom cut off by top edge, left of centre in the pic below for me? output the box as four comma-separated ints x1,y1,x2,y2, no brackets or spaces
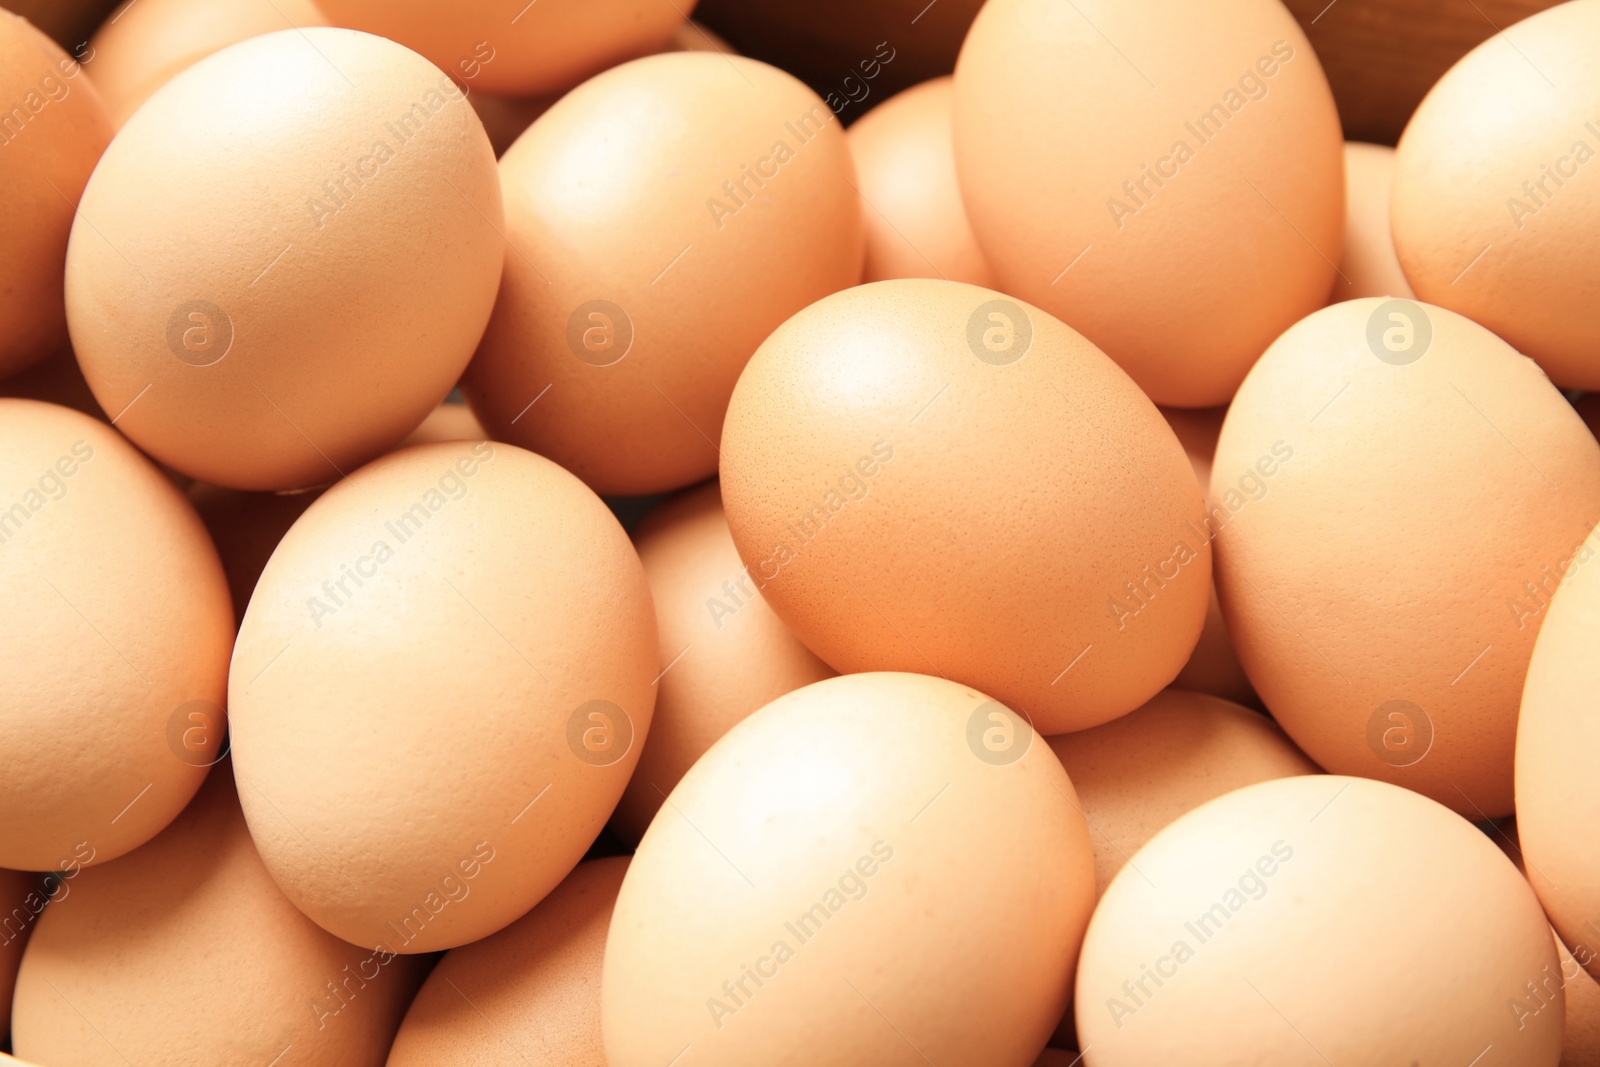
318,0,696,96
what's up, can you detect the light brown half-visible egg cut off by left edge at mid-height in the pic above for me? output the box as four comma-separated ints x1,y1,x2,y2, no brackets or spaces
0,400,234,870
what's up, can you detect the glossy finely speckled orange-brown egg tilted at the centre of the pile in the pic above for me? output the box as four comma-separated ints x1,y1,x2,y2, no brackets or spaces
722,278,1211,733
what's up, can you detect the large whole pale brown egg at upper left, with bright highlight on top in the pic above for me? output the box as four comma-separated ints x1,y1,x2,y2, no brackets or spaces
67,27,504,490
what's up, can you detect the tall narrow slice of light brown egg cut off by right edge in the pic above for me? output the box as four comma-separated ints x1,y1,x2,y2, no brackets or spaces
1517,530,1600,977
